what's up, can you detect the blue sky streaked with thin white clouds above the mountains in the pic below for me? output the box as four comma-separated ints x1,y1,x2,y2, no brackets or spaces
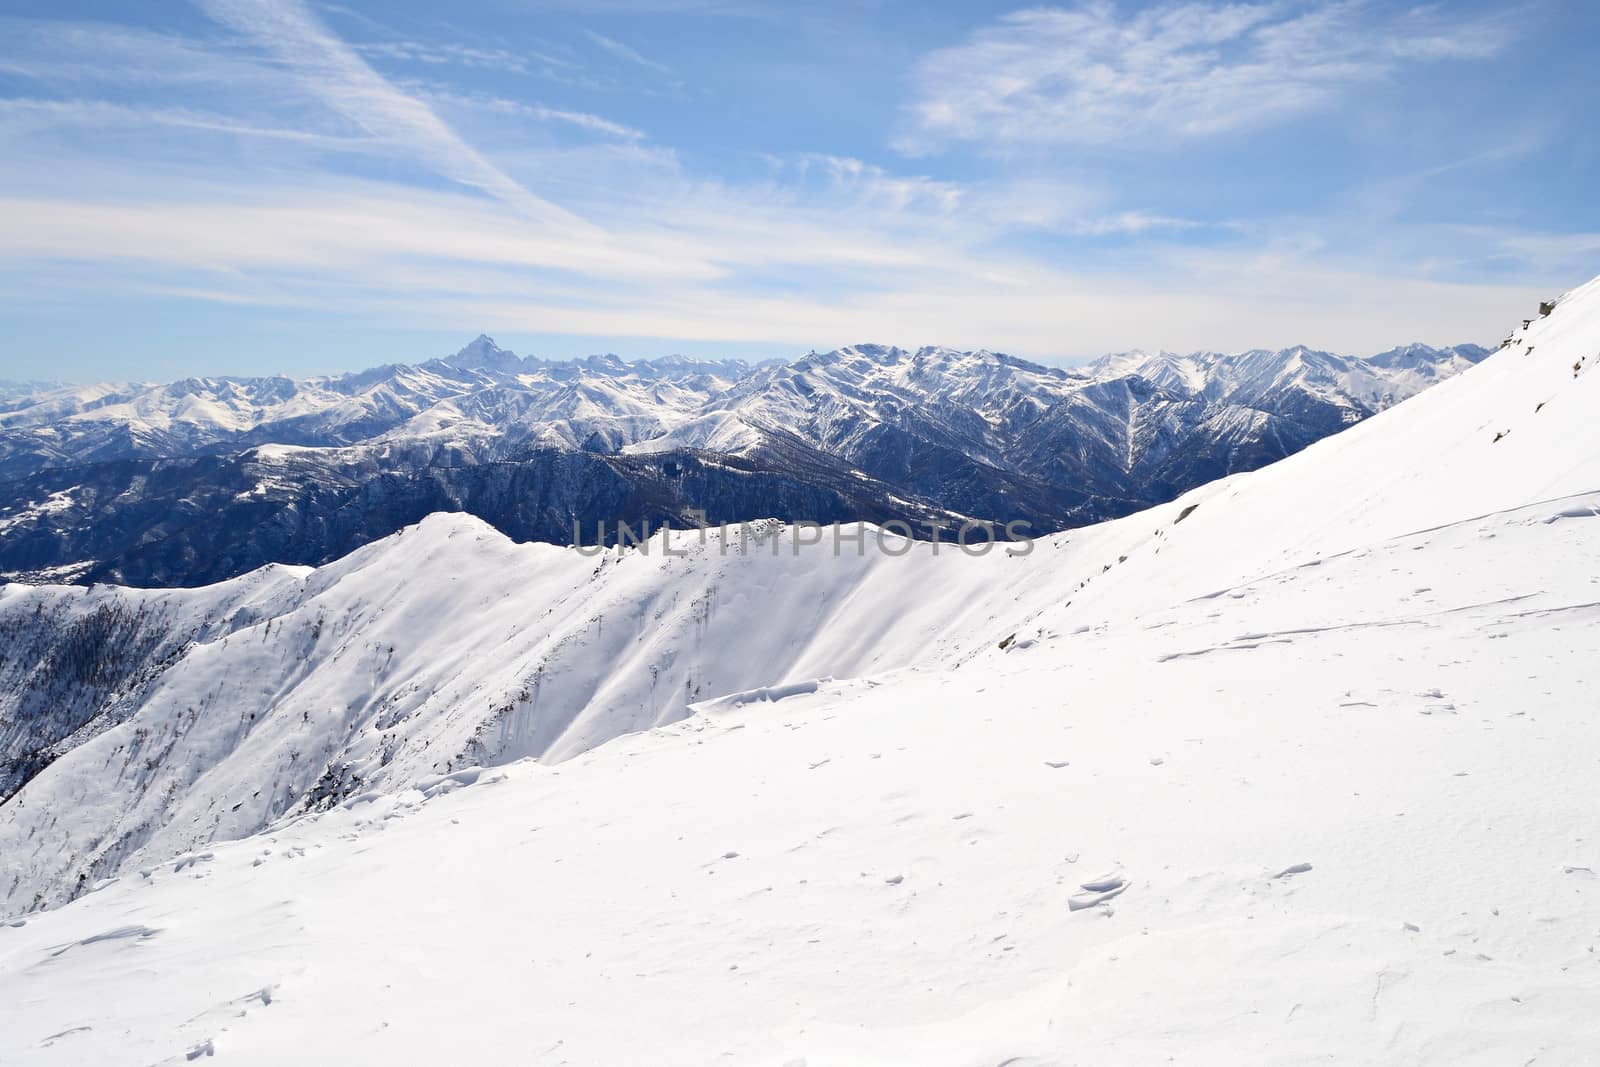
0,0,1600,381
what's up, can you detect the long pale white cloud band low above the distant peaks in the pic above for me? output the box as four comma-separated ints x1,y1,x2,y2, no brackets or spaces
0,155,1561,357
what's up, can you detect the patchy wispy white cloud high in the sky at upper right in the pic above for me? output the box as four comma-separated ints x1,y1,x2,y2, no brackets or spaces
899,0,1507,154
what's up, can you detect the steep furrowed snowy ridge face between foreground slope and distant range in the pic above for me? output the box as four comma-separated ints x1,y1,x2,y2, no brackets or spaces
0,515,1075,910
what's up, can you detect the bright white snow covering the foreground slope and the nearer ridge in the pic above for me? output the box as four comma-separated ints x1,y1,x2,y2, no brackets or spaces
0,282,1600,1067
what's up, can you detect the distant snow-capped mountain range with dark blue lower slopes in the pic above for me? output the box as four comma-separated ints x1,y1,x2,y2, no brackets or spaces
0,338,1486,585
